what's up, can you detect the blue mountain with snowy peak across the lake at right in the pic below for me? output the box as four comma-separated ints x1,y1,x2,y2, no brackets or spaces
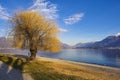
75,33,120,48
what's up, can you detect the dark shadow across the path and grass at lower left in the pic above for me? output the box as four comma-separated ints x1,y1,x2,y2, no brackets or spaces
0,56,27,80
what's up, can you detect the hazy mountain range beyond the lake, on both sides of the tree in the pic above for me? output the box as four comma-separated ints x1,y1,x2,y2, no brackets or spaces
0,33,120,49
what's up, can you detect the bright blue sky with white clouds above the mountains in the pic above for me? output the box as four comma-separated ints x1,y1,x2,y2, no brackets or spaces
0,0,120,45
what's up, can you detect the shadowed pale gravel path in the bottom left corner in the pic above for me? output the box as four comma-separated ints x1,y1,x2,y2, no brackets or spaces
0,61,33,80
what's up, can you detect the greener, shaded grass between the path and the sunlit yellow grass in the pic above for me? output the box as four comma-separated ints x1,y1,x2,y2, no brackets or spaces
0,55,88,80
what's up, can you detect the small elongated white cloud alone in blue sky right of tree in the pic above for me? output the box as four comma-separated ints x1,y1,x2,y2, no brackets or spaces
64,13,84,25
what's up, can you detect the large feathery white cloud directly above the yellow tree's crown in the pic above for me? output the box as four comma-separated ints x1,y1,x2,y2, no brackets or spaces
29,0,58,20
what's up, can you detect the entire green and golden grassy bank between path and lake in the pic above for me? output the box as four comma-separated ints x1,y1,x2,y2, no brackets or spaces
0,55,120,80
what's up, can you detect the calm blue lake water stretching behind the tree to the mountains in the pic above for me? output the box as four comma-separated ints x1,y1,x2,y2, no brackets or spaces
0,49,120,68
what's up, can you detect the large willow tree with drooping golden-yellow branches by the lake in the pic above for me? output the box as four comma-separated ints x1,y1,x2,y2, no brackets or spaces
10,11,61,59
